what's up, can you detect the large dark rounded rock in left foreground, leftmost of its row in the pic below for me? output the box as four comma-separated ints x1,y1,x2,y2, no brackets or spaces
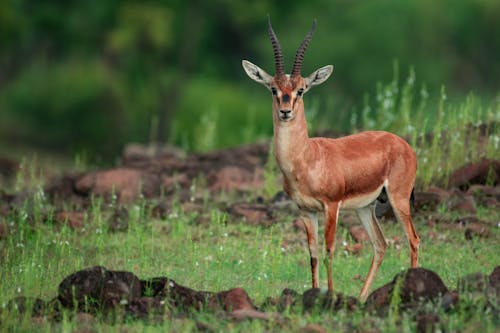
59,266,142,313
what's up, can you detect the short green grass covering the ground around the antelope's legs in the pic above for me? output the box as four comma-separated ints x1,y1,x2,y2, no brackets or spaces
0,185,500,331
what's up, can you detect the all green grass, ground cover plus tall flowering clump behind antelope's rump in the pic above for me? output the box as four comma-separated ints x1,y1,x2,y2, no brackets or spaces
0,76,500,332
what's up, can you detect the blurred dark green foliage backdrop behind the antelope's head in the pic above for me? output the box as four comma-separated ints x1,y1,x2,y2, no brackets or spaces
0,0,500,160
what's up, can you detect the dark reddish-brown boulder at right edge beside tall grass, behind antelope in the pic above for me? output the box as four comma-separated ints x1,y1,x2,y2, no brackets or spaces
448,158,500,189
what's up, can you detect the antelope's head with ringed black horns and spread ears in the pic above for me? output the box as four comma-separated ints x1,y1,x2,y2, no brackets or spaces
242,16,333,122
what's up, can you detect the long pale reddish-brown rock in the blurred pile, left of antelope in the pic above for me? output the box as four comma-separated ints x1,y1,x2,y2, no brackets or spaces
75,168,160,203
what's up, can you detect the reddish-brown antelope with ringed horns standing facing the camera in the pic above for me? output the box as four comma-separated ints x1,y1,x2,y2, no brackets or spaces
242,16,420,302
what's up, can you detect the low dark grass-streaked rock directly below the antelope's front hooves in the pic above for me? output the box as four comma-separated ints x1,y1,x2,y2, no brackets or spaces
302,288,359,312
